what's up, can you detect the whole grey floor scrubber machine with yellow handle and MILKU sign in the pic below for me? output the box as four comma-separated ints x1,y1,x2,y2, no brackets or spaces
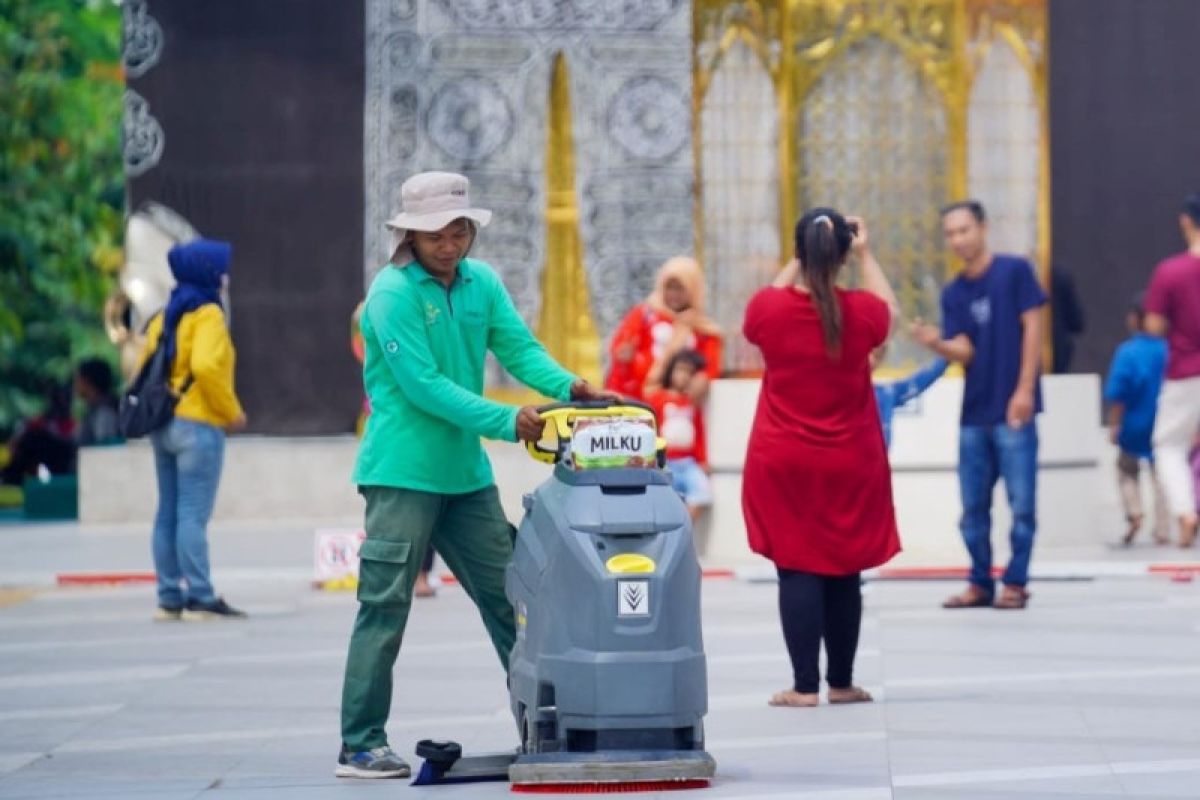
419,402,716,792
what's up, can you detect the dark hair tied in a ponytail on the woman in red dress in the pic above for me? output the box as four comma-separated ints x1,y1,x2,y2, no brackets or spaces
796,209,853,359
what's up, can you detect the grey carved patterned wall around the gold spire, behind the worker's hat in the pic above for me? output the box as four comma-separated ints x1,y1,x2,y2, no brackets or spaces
364,0,694,336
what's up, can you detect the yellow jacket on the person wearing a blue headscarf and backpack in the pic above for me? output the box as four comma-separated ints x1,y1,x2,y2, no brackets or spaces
138,303,242,428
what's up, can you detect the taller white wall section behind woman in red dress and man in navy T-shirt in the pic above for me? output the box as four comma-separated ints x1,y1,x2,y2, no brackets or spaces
707,375,1116,564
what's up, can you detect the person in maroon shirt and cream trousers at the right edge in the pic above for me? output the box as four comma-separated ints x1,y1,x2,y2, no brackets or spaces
1146,192,1200,547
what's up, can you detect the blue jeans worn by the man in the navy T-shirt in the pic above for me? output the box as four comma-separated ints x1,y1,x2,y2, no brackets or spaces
959,422,1038,594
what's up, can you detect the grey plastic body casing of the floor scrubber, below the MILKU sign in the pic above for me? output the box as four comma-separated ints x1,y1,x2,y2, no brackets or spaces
505,463,712,763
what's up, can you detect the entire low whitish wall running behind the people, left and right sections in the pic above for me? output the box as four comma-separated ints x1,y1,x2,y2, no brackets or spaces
79,375,1120,573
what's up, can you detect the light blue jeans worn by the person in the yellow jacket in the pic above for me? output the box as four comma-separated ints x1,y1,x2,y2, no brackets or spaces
150,417,224,608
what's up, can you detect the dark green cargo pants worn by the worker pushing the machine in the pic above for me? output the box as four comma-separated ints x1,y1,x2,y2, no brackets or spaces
342,486,516,751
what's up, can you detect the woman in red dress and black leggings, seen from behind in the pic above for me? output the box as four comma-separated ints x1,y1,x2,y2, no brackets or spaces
742,209,900,706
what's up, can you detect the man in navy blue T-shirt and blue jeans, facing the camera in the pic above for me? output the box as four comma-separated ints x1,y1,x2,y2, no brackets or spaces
912,200,1046,608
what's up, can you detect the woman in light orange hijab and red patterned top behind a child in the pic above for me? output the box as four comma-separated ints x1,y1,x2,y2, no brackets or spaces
605,255,721,463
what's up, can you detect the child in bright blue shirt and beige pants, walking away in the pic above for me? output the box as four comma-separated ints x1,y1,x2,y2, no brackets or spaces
1104,296,1171,545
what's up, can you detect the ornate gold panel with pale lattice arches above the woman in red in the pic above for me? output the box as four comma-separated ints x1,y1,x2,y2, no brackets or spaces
692,0,1049,372
